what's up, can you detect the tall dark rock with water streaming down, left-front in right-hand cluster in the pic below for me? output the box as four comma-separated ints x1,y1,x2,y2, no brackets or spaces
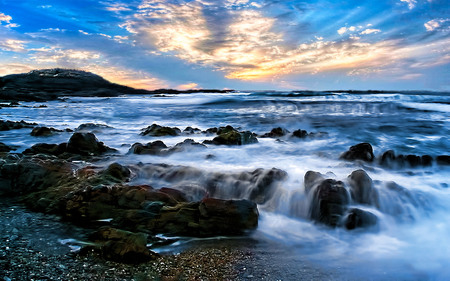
309,176,349,226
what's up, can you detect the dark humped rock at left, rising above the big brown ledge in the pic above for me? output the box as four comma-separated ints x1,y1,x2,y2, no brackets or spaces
66,132,115,155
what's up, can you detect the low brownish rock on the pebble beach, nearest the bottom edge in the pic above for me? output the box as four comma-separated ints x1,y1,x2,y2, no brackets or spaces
89,227,158,264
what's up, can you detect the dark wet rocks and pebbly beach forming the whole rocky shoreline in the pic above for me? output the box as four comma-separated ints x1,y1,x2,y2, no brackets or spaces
0,116,448,280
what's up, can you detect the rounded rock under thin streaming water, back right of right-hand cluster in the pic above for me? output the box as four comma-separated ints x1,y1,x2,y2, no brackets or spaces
348,170,379,207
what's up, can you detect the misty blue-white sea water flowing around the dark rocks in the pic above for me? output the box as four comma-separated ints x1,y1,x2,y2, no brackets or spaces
0,92,450,280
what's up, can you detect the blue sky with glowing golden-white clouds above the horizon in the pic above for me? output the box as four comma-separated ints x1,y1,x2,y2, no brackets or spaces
0,0,450,91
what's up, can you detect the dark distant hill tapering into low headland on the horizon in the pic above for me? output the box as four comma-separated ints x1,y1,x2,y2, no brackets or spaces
0,68,229,101
